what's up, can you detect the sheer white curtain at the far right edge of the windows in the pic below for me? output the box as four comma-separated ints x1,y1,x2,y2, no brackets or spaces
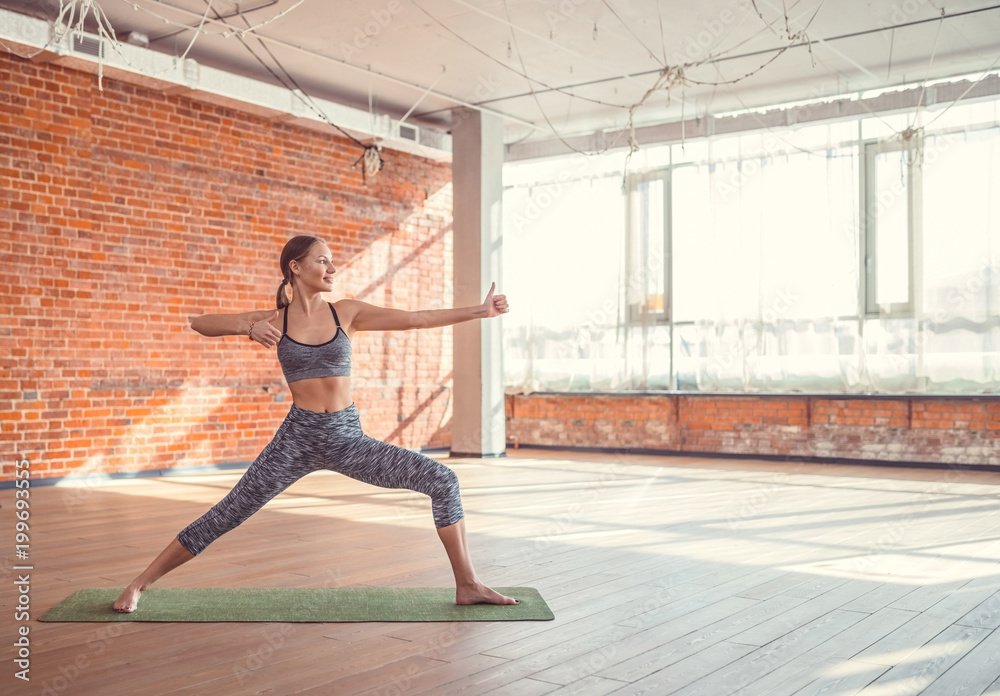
884,128,1000,392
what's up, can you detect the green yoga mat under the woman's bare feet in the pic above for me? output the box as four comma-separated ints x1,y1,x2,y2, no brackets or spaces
39,587,555,623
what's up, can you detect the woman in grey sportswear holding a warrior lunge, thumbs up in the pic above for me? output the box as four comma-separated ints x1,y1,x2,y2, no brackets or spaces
114,236,517,612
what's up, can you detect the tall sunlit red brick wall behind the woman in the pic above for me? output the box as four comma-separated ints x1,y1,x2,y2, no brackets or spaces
0,55,451,480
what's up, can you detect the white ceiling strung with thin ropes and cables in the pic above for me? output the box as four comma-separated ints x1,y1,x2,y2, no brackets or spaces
0,0,1000,143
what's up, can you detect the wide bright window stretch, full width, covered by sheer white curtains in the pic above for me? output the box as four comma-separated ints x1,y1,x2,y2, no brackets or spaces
504,108,1000,393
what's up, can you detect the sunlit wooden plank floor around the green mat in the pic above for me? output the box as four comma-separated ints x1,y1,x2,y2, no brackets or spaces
0,450,1000,696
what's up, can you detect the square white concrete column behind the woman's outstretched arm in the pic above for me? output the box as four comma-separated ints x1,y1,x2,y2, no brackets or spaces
451,109,507,457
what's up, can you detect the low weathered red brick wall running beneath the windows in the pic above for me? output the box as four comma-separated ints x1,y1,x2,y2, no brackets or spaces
507,394,1000,465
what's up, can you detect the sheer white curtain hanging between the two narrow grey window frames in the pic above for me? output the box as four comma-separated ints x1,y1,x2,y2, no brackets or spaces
672,136,860,392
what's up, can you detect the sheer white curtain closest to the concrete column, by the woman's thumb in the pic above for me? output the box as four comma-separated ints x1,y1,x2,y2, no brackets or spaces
503,161,625,392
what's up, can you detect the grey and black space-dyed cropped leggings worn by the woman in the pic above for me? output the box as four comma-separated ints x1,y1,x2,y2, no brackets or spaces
177,404,464,556
